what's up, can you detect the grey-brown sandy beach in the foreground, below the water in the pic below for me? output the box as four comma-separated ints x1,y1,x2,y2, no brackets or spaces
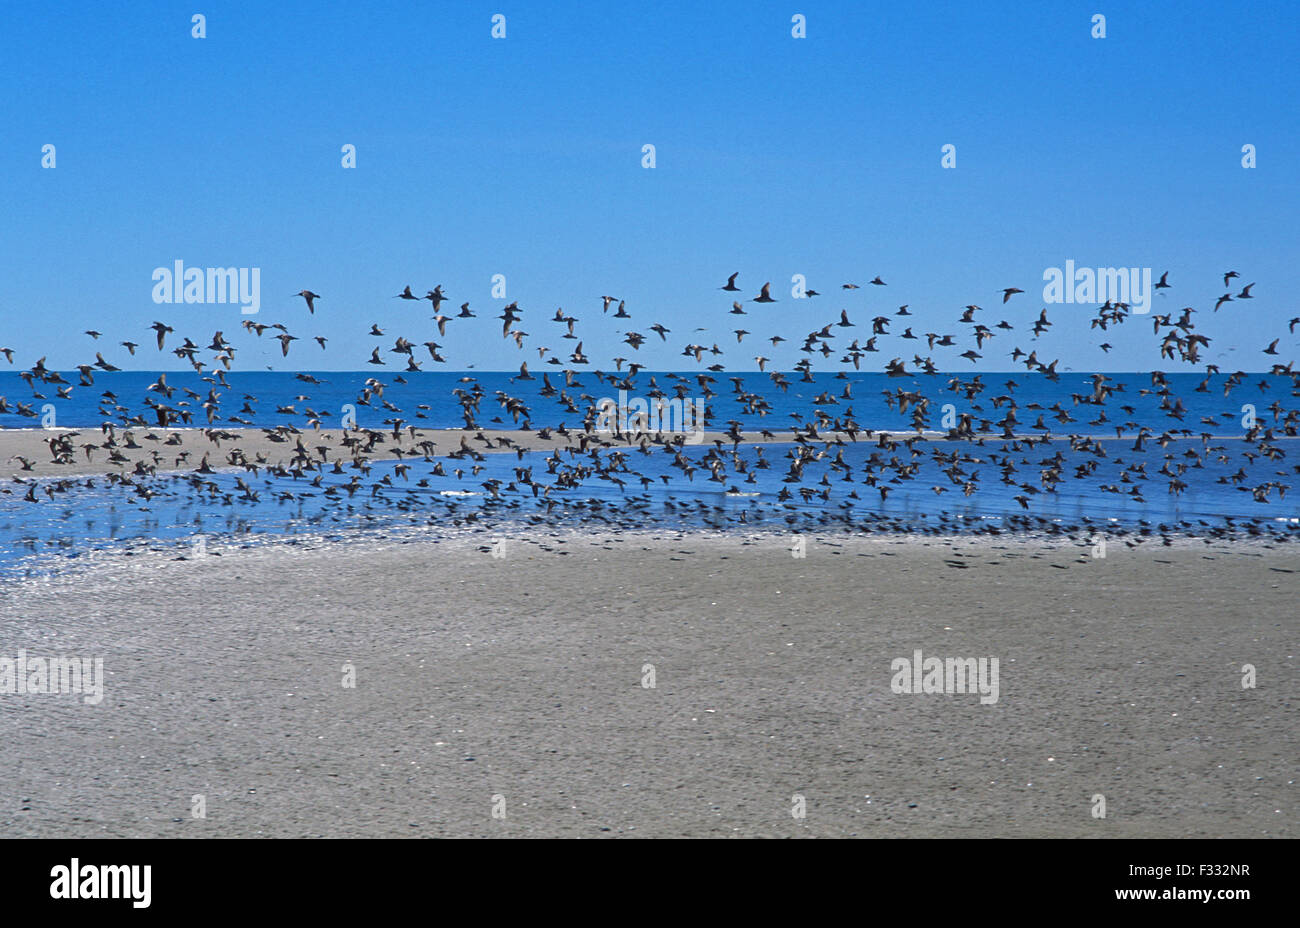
0,532,1300,837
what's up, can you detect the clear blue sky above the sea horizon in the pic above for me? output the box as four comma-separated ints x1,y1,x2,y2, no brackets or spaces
0,0,1300,372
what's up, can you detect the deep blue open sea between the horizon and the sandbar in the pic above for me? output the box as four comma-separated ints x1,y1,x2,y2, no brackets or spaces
0,369,1297,434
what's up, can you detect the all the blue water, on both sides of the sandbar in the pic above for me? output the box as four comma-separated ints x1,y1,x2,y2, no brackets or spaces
0,372,1300,568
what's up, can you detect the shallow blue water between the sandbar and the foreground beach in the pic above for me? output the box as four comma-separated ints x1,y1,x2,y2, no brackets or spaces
0,439,1300,568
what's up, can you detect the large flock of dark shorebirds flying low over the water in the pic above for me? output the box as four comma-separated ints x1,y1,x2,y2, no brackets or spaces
0,272,1300,542
